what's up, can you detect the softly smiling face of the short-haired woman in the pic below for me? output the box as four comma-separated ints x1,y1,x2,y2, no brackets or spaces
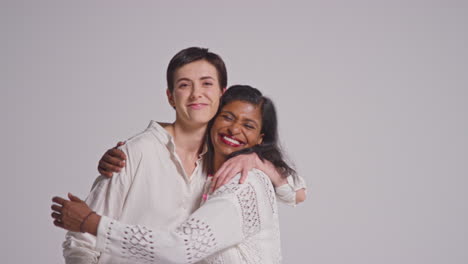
167,60,222,125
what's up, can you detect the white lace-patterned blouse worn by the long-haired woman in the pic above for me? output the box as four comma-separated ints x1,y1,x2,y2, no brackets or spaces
96,169,281,264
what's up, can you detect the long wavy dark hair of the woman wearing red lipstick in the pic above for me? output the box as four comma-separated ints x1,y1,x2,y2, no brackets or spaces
204,85,296,177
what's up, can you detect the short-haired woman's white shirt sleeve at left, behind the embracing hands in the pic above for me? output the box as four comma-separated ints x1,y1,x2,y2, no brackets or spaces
62,144,136,264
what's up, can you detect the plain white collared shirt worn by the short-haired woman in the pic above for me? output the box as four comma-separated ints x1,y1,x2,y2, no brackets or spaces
63,121,206,264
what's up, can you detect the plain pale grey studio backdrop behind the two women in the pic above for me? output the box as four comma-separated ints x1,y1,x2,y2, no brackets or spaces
0,0,468,264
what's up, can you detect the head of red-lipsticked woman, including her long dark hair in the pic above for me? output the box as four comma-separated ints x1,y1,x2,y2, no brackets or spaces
204,85,296,178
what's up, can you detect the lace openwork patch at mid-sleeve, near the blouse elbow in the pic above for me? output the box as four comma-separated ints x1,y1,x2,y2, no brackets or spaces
176,218,217,263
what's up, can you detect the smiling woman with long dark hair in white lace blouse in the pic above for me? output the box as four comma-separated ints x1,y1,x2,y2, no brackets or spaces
52,85,295,263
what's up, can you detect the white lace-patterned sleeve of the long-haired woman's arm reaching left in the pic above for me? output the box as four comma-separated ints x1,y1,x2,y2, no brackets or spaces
96,172,276,263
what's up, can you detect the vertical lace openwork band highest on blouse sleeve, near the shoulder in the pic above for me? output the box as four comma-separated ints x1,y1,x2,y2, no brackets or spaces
236,183,260,237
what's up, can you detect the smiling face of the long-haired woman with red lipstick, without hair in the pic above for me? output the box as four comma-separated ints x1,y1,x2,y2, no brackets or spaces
210,101,263,157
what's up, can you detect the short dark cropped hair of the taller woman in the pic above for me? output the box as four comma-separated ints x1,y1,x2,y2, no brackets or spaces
166,47,227,93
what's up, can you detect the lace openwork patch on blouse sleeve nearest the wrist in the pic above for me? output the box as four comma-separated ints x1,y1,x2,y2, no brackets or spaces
122,225,154,262
